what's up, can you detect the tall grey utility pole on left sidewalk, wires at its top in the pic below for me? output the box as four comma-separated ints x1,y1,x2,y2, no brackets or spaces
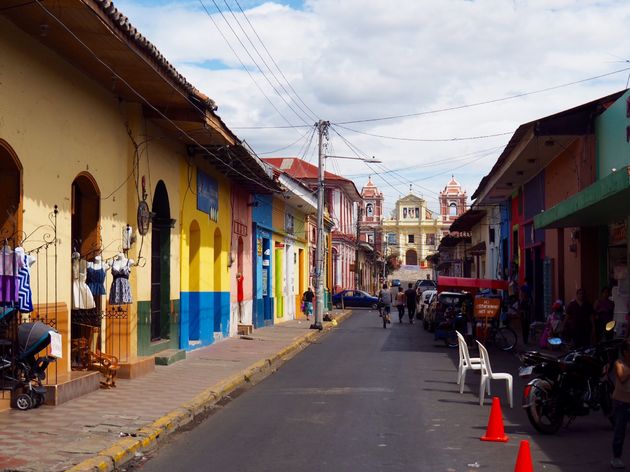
311,120,330,330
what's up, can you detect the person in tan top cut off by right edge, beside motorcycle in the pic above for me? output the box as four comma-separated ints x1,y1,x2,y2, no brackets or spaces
610,339,630,469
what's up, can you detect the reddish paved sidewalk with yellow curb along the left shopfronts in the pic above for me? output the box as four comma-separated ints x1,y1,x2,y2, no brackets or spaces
0,311,351,472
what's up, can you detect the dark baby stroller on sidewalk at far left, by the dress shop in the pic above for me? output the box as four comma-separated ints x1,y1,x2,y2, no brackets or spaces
0,321,55,410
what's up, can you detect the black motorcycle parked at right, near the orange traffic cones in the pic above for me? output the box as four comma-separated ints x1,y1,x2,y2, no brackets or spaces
519,321,623,434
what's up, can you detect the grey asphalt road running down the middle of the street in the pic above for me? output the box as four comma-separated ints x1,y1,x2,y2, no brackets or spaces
139,310,630,472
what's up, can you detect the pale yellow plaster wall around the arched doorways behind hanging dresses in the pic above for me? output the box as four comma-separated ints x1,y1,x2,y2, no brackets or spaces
0,18,184,371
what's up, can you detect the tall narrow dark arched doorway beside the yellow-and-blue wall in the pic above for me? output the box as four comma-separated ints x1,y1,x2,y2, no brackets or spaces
151,180,173,341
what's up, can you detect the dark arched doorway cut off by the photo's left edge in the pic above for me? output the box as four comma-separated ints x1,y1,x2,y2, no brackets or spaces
0,139,22,236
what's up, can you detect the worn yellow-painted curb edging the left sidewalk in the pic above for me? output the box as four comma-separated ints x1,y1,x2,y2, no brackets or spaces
66,310,352,472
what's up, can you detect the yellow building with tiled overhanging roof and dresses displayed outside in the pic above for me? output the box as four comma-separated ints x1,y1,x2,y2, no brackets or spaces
0,0,277,408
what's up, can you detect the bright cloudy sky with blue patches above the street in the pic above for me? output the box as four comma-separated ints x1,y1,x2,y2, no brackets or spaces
115,0,630,214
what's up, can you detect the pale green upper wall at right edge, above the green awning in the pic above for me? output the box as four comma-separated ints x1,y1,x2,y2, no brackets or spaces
595,91,630,179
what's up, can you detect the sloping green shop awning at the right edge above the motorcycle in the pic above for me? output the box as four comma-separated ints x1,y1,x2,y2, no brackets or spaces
534,167,630,229
